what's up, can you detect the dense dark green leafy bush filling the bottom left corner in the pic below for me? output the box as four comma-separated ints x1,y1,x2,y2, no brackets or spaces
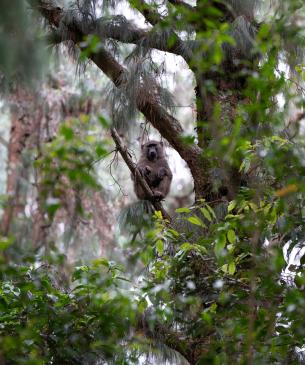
0,249,136,364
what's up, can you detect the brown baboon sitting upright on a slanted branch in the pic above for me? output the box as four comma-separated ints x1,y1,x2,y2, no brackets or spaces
132,141,173,201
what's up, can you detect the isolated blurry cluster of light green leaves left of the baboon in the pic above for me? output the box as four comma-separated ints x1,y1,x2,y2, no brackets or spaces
35,115,108,217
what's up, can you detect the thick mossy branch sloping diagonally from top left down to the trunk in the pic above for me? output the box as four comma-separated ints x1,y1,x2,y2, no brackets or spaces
28,0,209,198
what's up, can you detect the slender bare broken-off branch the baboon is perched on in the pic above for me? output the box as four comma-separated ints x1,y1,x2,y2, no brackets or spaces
111,128,171,221
